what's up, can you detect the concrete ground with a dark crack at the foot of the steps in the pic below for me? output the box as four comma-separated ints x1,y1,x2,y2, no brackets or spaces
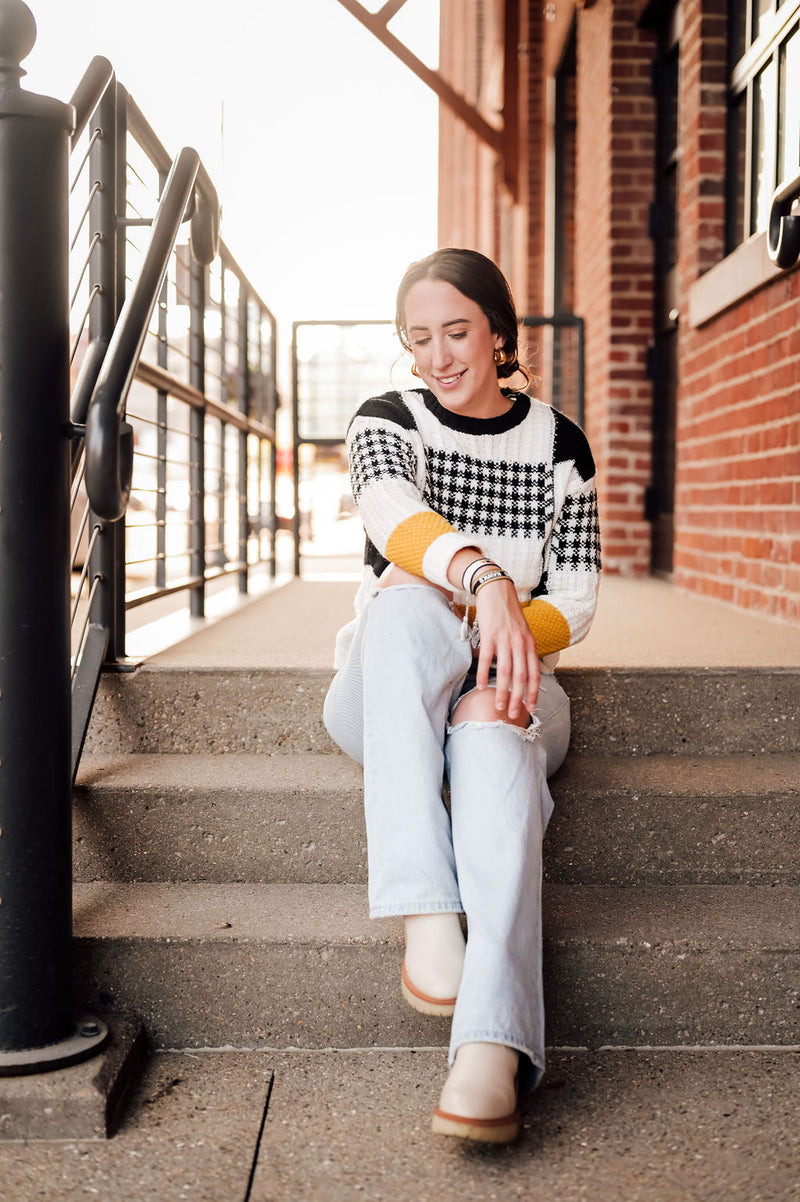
2,1047,800,1202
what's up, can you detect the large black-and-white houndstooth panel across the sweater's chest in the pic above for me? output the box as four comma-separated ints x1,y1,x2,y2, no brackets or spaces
424,450,555,538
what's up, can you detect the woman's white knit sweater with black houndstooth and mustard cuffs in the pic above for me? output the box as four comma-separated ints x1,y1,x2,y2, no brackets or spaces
336,388,601,660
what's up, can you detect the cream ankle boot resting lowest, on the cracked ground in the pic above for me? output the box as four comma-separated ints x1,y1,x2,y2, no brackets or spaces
432,1043,520,1143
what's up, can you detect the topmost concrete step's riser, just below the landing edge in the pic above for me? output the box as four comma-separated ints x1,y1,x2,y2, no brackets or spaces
86,664,800,755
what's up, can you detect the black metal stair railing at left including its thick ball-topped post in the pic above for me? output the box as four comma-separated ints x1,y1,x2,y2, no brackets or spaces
0,0,277,1075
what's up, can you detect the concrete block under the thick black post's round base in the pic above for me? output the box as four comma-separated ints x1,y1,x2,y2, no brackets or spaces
0,1017,147,1142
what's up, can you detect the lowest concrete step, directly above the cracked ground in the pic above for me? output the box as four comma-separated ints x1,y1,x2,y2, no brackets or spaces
74,882,800,1048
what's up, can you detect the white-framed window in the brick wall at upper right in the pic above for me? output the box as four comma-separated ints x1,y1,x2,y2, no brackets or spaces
727,0,800,251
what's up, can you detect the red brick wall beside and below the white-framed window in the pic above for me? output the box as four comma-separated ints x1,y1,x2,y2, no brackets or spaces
675,0,800,621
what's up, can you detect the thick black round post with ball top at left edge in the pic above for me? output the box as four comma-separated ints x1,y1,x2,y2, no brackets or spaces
0,0,103,1073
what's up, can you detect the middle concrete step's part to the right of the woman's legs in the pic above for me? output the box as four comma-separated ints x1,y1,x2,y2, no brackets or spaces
544,752,800,886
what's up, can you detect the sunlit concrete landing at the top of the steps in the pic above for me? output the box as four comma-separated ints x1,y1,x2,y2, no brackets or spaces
147,576,800,668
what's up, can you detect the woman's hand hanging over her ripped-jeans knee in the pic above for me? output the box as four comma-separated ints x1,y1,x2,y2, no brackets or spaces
476,581,539,719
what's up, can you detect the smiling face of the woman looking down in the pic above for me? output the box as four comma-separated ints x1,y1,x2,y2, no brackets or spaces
405,280,509,417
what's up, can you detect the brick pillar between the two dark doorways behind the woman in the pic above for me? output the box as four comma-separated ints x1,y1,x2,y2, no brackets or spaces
575,0,655,575
